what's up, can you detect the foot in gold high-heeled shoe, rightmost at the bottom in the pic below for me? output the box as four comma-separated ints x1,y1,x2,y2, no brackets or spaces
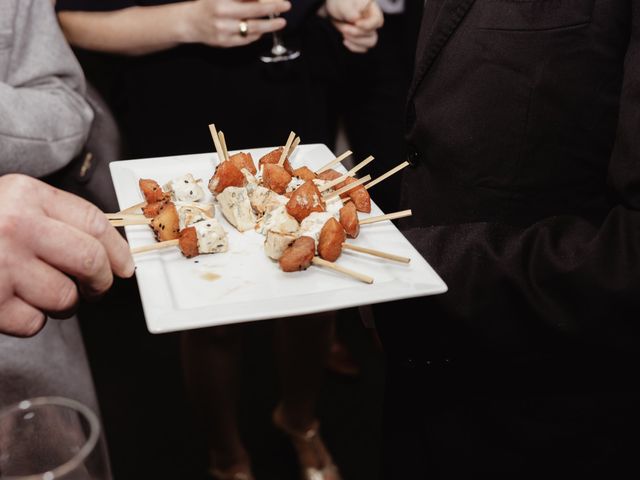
273,407,342,480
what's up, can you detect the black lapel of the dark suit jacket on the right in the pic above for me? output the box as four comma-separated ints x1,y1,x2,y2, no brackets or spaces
408,0,475,99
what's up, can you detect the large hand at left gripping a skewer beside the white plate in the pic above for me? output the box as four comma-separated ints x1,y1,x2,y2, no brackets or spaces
0,175,134,336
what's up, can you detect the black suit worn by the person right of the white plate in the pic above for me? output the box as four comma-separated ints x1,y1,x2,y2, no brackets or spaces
376,0,640,478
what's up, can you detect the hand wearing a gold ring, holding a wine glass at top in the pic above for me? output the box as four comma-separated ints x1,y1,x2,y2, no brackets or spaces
185,0,291,47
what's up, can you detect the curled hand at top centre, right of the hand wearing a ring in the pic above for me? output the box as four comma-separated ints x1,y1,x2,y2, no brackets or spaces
325,0,384,53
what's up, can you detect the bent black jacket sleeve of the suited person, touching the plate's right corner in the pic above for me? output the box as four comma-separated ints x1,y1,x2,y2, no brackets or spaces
405,2,640,350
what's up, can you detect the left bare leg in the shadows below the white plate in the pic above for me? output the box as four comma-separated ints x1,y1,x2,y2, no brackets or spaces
181,325,249,473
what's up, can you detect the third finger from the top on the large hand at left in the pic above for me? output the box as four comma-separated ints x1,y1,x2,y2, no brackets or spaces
13,258,78,318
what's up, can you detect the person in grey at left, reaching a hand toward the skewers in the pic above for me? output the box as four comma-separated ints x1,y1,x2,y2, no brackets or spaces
0,0,133,462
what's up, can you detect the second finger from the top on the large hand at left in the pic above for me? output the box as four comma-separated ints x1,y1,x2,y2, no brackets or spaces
26,218,113,295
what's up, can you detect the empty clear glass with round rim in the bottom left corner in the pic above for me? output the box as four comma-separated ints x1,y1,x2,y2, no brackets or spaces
0,397,111,480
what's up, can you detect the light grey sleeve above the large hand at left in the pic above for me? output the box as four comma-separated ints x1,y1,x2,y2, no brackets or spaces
0,0,93,177
